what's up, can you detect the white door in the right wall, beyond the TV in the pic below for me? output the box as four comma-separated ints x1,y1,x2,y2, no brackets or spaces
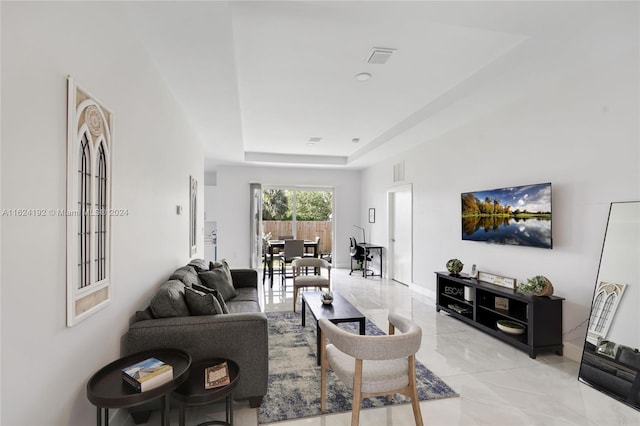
388,186,413,284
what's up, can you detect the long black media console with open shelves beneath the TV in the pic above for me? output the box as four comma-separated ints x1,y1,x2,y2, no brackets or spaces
436,272,564,358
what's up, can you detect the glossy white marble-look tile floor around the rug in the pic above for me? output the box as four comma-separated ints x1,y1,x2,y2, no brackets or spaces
126,269,640,426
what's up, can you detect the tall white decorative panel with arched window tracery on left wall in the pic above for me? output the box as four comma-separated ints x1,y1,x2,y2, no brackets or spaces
64,77,113,327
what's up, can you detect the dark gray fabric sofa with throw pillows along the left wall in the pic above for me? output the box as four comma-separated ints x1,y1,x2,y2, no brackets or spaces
122,259,269,423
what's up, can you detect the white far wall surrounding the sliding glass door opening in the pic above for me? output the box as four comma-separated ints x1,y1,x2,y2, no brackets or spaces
217,166,362,268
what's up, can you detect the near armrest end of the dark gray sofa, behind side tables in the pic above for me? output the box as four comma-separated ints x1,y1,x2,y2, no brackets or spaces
122,310,269,400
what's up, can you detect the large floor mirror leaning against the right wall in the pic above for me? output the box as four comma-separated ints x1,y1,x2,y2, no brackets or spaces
578,202,640,410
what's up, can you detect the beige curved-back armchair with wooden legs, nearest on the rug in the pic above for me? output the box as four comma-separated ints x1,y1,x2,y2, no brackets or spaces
319,313,423,426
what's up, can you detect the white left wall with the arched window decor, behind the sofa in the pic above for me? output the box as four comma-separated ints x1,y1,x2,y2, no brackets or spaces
0,2,204,425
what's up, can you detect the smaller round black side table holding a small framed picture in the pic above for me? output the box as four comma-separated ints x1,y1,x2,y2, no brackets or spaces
173,358,240,426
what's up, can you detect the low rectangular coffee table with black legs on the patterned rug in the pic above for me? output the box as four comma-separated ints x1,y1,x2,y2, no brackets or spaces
302,291,365,365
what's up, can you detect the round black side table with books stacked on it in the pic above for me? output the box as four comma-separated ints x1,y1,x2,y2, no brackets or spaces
87,349,191,426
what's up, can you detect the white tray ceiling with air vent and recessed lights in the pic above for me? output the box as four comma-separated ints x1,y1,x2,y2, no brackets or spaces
124,1,639,171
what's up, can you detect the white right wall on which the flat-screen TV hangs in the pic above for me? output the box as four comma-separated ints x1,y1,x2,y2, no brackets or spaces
362,52,640,356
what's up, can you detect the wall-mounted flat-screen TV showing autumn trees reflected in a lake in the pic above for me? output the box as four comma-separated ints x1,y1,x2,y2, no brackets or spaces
462,183,553,249
